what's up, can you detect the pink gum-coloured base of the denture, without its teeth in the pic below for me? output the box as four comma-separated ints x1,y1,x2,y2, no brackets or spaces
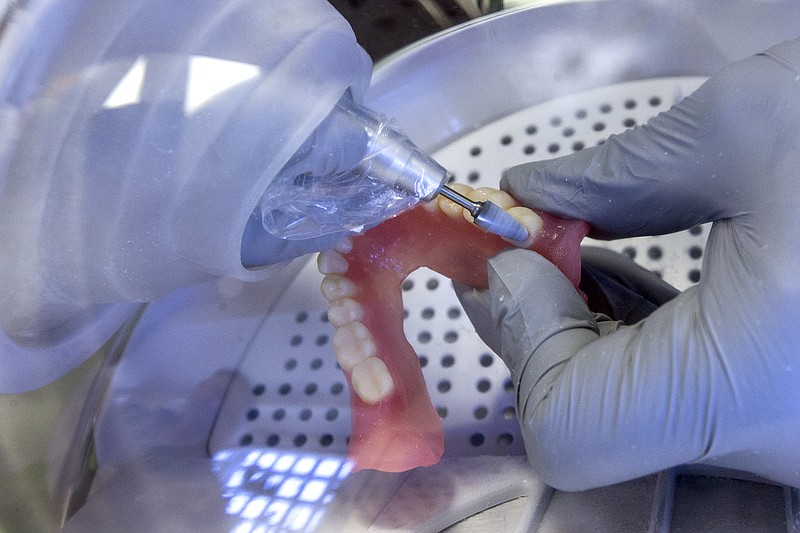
338,207,589,472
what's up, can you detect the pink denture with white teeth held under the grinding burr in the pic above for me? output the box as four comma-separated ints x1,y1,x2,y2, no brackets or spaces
318,184,589,472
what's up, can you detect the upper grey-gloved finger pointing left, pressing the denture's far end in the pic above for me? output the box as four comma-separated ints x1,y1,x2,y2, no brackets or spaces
500,88,721,238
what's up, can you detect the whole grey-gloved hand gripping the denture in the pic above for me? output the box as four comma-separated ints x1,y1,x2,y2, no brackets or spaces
460,40,800,490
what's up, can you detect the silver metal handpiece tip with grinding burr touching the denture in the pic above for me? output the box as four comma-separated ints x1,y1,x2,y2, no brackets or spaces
340,97,528,242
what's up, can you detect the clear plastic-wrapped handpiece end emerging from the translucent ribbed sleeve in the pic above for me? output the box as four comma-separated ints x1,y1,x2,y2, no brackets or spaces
256,95,448,240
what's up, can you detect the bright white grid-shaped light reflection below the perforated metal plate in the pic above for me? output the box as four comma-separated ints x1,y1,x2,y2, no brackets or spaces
212,448,352,533
